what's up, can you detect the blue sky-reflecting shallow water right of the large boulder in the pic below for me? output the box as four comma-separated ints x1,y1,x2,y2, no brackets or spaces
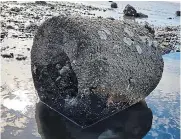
144,53,180,139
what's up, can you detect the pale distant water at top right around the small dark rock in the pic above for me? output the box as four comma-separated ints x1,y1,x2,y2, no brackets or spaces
75,1,180,26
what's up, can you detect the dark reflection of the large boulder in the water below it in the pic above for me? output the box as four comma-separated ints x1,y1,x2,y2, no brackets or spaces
35,101,153,139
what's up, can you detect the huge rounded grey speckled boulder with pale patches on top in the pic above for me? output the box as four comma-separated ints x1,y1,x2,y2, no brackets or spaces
31,15,163,128
